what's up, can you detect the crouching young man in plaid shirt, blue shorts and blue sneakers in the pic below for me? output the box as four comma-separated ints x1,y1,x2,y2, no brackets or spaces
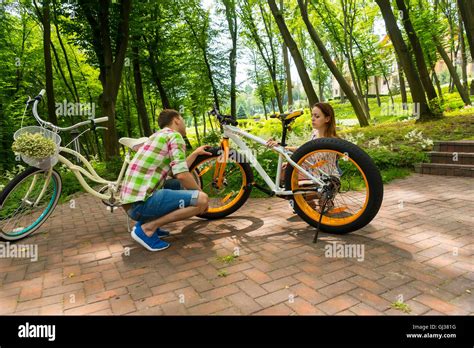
121,109,210,251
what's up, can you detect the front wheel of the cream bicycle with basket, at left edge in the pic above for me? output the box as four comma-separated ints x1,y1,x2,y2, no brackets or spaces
0,167,62,240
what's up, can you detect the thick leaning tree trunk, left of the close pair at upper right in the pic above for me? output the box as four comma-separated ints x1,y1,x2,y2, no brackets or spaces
375,0,436,121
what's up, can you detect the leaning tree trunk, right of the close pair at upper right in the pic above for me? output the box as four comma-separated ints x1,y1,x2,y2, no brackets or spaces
397,0,441,106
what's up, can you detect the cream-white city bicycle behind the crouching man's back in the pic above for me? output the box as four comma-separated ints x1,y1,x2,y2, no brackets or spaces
0,90,148,241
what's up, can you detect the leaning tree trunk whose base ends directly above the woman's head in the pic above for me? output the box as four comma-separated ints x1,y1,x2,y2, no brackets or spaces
268,0,319,105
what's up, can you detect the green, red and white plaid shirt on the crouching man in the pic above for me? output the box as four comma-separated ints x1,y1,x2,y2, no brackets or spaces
120,127,189,204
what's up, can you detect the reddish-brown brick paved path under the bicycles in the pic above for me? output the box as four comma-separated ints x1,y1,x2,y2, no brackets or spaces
0,174,474,315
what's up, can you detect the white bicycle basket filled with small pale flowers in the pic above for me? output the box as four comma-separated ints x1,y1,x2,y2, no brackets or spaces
12,126,61,170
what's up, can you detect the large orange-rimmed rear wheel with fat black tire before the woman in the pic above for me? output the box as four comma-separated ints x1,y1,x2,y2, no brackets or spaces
285,138,383,234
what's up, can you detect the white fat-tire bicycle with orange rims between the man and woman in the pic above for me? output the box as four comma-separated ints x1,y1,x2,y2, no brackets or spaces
190,107,383,240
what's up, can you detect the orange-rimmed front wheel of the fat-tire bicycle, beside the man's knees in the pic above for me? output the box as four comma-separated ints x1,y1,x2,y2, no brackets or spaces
190,149,253,219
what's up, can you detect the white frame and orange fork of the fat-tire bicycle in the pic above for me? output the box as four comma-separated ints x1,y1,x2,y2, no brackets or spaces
214,124,326,196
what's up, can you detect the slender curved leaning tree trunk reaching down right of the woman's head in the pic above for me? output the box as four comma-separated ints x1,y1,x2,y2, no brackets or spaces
298,0,369,127
